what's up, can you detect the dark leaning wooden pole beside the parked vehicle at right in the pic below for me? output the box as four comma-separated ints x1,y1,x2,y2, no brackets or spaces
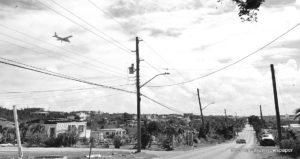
271,64,282,143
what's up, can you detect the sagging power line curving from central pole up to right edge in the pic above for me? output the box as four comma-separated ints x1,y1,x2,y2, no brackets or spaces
152,23,300,87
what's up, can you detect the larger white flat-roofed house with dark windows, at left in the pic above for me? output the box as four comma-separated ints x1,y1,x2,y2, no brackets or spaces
26,118,87,138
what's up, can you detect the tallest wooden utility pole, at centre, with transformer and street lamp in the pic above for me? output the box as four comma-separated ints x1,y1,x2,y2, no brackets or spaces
135,37,142,152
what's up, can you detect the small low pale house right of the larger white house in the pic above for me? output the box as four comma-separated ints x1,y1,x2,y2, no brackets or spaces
91,128,126,141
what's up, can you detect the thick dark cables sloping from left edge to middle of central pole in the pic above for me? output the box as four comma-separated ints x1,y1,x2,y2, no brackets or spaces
0,58,135,94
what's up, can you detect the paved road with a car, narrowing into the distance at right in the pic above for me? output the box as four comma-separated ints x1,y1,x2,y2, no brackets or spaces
149,125,261,159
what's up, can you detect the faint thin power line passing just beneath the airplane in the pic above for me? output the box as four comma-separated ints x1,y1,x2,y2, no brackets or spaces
0,24,129,77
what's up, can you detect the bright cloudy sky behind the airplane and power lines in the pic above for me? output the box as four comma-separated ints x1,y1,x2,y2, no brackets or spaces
0,0,300,116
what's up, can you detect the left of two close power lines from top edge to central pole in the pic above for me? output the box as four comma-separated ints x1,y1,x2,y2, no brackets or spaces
37,0,133,55
